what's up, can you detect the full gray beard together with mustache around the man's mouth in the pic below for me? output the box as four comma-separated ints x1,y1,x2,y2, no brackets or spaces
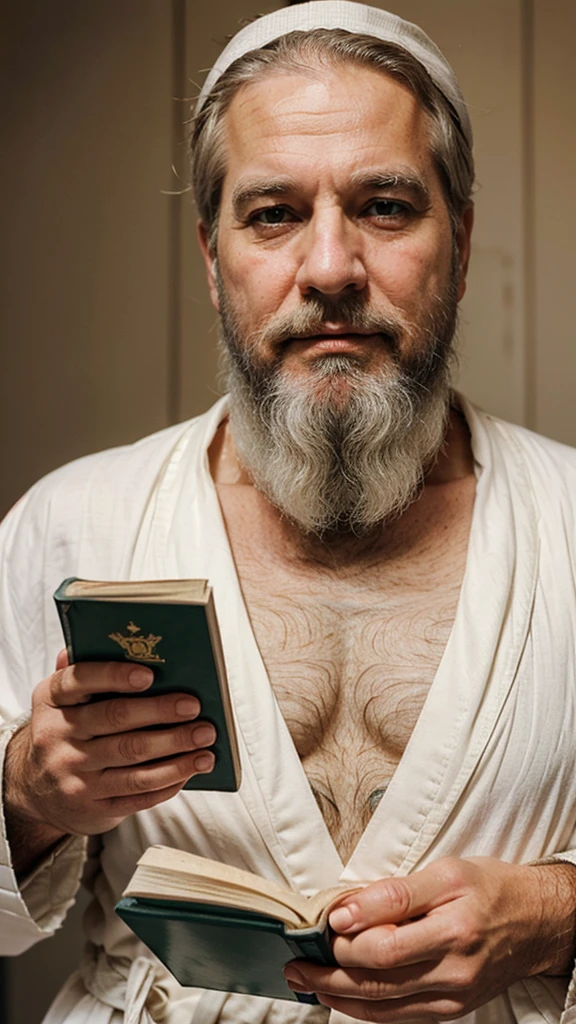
216,289,456,538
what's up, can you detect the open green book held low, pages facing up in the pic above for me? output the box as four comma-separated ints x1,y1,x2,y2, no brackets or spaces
116,846,359,1002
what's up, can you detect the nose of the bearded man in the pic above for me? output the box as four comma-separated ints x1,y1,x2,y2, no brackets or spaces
296,208,367,295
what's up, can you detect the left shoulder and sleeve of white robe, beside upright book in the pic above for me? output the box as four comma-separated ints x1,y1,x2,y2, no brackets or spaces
0,425,188,955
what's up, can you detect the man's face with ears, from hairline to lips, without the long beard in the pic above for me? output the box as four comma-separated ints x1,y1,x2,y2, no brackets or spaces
201,68,468,386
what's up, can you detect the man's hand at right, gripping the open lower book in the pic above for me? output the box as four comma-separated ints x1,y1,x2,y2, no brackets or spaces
285,857,576,1024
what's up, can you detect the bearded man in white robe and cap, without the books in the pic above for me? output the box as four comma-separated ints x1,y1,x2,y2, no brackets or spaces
0,6,576,1024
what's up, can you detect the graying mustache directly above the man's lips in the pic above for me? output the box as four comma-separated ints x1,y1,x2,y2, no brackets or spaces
250,295,405,352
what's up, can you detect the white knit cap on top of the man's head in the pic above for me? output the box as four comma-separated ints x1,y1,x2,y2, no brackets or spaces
197,0,472,146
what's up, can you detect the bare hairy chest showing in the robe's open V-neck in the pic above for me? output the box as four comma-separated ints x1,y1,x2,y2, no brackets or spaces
220,475,468,862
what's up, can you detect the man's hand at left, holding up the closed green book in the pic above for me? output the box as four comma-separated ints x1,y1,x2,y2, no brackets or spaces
5,651,215,868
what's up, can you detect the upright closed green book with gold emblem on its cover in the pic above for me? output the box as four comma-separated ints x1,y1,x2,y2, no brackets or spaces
54,577,241,792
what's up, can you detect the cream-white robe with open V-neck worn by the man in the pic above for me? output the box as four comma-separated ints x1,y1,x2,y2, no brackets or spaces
0,393,576,1024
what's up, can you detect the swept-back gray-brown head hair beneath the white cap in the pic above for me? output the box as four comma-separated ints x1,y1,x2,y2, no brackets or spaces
191,29,475,252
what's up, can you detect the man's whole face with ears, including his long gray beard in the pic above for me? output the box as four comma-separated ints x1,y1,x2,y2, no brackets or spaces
200,67,471,537
